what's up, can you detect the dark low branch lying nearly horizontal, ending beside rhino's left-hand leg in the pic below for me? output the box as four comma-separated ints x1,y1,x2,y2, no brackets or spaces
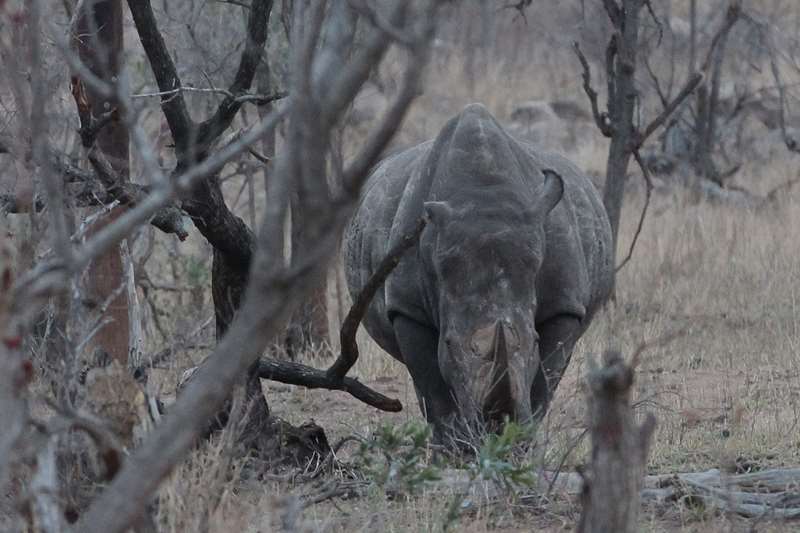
258,358,403,413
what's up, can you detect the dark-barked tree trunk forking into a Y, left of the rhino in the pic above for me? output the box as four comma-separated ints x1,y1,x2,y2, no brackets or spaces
128,0,272,444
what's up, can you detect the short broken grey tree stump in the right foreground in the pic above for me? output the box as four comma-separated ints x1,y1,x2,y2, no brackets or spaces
578,352,655,533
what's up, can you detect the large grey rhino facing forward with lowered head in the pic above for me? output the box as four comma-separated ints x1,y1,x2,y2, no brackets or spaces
345,104,613,435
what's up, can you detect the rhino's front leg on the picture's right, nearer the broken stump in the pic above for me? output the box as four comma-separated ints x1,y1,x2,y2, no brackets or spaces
531,315,581,420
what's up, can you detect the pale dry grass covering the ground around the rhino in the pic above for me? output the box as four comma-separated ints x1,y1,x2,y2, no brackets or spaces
125,3,800,532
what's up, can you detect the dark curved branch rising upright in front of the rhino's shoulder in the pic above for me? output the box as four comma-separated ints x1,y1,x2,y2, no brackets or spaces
326,214,428,381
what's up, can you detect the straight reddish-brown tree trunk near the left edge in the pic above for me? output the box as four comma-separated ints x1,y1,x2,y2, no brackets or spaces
73,0,145,454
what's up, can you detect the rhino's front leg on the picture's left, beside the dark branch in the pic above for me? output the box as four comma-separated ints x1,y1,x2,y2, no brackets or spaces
392,316,456,437
